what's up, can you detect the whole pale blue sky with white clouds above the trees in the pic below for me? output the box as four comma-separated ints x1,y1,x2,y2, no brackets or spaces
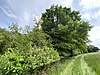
0,0,100,48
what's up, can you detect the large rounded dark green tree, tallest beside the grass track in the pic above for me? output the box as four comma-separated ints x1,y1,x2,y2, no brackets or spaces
41,5,91,56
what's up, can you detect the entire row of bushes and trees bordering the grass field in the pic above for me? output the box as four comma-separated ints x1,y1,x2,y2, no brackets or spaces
0,5,99,75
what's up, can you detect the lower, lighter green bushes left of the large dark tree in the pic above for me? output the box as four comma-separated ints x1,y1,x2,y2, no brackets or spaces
0,24,60,75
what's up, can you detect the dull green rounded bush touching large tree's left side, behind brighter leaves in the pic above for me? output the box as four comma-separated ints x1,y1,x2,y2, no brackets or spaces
28,28,52,47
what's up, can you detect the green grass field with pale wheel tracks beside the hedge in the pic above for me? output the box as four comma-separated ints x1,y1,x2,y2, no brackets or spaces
49,52,100,75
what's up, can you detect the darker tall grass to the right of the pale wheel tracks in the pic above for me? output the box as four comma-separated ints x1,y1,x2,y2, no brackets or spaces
84,53,100,75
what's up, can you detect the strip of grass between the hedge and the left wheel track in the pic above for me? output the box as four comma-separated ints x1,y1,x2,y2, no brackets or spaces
48,57,74,75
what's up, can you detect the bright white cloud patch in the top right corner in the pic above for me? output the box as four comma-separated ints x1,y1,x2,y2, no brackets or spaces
80,0,100,9
